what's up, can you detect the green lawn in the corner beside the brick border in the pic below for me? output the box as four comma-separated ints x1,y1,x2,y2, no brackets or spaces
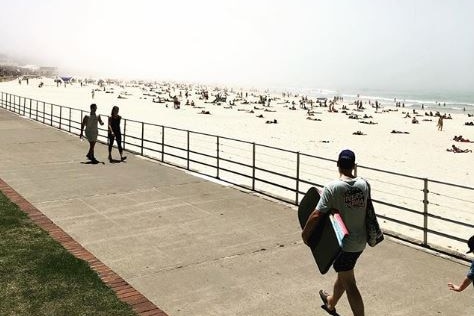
0,192,136,316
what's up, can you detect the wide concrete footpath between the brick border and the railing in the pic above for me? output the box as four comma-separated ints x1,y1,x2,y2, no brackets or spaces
0,109,474,316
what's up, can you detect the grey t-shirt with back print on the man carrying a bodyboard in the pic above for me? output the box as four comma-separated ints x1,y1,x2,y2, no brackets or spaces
316,177,369,252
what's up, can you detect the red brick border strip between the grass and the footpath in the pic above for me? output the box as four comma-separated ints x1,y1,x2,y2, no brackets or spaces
0,178,168,316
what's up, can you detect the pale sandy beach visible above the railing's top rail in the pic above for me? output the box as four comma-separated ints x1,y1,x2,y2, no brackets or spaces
0,79,474,186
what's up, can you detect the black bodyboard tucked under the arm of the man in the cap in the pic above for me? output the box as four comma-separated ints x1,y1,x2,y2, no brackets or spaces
298,187,347,274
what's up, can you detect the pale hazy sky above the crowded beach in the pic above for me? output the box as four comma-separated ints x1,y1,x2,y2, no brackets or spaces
0,0,474,90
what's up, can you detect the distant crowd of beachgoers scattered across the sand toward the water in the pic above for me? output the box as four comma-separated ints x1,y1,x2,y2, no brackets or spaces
12,77,474,157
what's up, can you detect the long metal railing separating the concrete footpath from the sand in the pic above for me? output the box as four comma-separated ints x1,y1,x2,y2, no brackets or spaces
0,92,474,259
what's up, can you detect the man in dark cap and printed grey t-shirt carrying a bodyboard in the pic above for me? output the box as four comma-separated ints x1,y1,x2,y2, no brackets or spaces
302,149,370,315
